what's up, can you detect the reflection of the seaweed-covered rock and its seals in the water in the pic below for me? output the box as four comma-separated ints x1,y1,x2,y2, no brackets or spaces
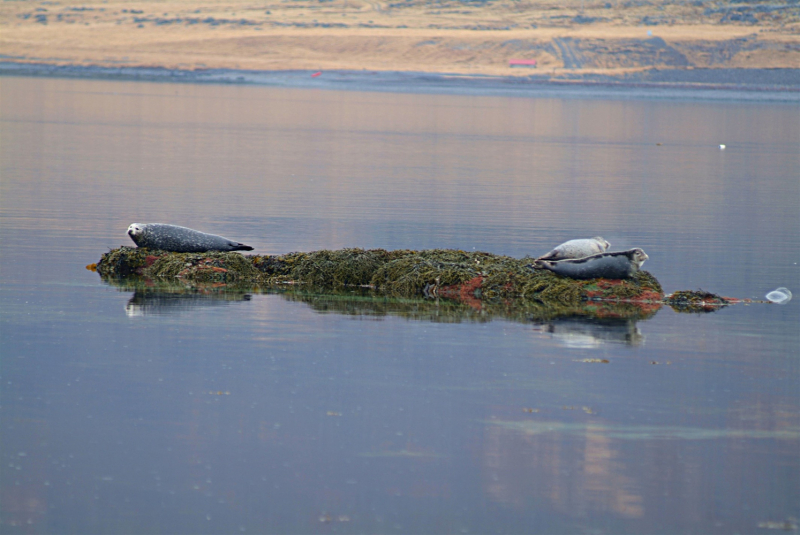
108,277,661,348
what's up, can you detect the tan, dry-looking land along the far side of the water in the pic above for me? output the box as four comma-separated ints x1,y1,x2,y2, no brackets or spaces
0,0,800,88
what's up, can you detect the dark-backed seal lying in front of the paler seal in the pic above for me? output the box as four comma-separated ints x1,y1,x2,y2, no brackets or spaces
534,248,650,280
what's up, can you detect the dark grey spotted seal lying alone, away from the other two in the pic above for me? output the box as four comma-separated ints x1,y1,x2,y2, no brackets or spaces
128,223,253,253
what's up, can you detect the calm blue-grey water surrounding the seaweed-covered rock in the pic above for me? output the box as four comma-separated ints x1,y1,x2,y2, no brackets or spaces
0,77,800,534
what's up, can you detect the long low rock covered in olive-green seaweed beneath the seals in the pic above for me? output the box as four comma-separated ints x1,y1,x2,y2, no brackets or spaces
97,247,663,305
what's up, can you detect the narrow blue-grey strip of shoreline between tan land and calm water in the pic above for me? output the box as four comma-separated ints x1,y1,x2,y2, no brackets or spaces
0,58,800,103
